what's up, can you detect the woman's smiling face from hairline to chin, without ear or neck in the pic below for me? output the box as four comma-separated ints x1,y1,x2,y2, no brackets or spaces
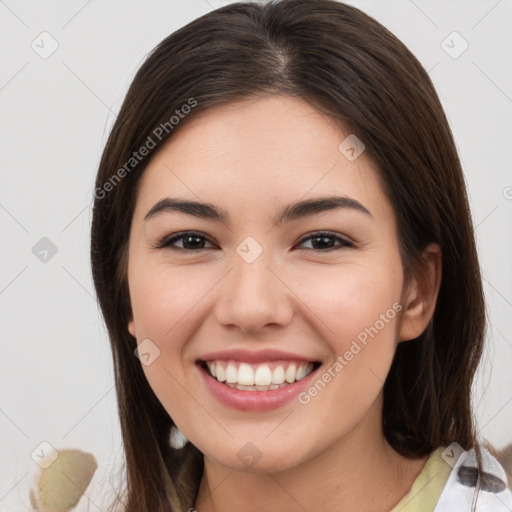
128,96,412,472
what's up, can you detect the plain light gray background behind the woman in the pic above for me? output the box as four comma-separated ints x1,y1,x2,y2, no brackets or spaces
0,0,512,512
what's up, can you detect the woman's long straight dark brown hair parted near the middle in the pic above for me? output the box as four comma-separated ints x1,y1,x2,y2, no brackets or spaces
91,0,485,512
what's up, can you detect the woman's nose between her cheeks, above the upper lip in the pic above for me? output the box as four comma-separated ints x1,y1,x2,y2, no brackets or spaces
215,246,293,333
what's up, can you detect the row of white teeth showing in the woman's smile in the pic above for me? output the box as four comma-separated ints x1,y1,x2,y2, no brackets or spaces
207,361,313,391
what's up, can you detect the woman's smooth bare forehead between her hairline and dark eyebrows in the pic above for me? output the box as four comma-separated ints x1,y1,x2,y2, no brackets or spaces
132,95,390,224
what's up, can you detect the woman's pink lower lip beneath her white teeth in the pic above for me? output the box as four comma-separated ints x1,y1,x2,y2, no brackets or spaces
198,365,320,411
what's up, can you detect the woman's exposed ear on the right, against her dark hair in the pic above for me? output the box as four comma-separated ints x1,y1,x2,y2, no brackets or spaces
399,244,442,341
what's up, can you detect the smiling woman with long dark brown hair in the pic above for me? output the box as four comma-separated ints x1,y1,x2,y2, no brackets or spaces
91,0,512,512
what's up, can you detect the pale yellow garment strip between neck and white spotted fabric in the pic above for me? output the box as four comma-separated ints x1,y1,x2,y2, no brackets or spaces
390,447,452,512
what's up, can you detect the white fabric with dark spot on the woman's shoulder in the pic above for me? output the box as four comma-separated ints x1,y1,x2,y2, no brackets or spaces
434,443,512,512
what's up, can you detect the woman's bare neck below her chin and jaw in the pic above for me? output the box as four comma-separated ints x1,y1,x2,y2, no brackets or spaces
194,398,428,512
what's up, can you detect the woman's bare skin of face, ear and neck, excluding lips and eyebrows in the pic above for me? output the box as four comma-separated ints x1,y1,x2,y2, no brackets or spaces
128,96,441,512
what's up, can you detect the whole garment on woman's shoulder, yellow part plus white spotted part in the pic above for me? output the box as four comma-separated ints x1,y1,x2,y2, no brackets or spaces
390,443,512,512
